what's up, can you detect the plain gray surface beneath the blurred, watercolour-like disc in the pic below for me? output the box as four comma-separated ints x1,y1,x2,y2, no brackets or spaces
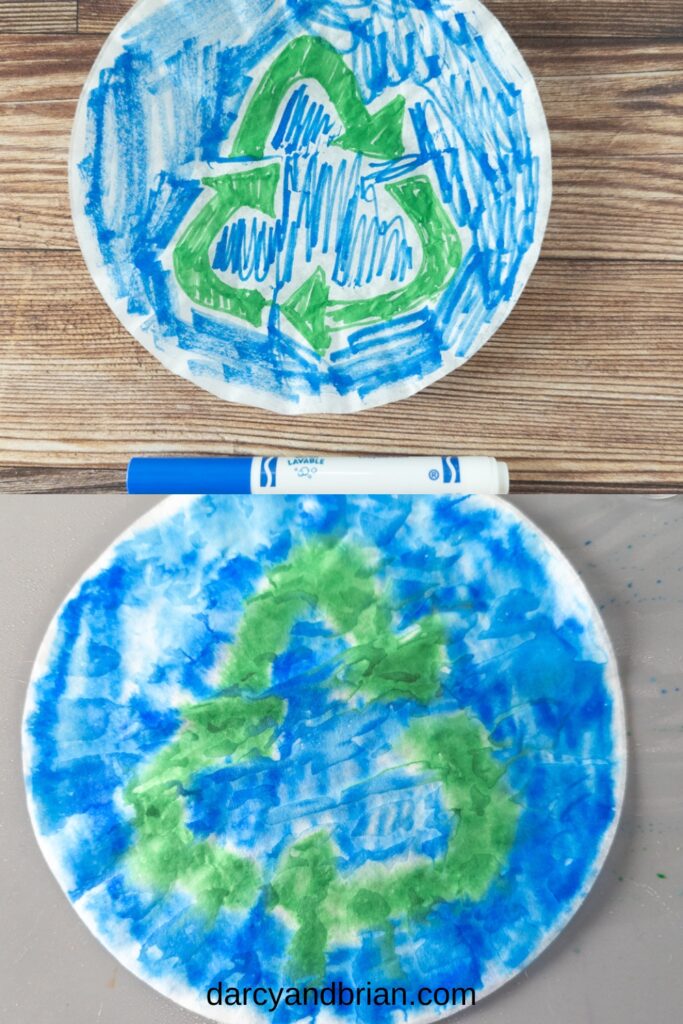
0,496,683,1024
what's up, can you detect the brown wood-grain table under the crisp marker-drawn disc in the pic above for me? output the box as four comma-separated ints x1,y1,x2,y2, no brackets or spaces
0,0,683,492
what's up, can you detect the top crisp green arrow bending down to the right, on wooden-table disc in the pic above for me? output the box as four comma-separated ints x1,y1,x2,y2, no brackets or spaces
232,36,405,160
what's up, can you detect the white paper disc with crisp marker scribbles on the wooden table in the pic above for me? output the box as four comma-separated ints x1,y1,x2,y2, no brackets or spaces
70,0,551,413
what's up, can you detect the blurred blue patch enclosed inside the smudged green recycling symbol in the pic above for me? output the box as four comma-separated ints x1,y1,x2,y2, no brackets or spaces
189,622,452,877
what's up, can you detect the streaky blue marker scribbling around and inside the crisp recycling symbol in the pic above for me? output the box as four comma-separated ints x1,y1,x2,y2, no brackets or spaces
78,0,540,406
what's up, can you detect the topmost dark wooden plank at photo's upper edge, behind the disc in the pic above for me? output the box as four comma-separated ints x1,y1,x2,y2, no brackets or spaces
79,0,683,40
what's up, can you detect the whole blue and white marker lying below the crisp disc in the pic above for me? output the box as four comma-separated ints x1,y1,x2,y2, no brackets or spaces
128,455,510,495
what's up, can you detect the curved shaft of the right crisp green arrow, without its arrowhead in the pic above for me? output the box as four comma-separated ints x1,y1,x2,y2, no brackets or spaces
328,174,463,331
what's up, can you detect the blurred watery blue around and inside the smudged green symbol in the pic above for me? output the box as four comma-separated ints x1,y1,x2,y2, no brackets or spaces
26,497,623,1024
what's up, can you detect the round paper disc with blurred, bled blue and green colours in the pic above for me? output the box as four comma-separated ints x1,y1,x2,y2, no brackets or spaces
24,498,626,1024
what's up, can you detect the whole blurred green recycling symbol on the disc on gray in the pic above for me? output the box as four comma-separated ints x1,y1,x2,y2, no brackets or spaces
124,540,520,981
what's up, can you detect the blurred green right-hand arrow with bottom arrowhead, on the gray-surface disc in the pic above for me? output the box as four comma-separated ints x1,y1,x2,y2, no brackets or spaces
270,712,520,979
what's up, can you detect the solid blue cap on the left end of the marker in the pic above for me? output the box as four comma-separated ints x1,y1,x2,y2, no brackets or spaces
126,458,252,495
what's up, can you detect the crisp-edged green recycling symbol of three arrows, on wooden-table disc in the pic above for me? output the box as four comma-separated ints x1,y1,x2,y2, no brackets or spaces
173,36,462,356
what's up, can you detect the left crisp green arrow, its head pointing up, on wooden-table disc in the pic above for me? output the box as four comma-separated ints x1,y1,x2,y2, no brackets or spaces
173,164,280,327
